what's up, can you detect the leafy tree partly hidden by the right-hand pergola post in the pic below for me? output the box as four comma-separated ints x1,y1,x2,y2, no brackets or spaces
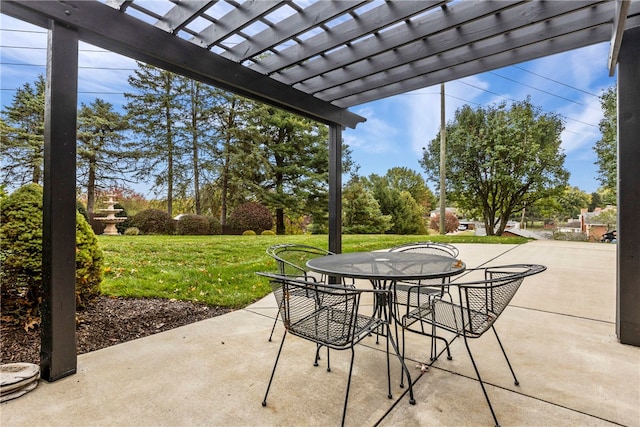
593,86,618,196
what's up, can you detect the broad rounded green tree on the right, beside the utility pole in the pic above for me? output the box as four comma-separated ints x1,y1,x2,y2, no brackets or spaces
420,98,569,235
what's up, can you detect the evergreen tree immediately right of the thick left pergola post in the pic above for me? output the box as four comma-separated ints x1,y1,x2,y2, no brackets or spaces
76,99,132,218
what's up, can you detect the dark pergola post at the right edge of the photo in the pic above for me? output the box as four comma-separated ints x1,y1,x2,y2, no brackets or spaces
616,27,640,346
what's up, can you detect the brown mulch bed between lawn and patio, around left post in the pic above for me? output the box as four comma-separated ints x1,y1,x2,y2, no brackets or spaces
0,296,232,364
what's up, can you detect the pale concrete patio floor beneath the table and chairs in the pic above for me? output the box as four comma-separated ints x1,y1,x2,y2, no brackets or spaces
0,241,640,427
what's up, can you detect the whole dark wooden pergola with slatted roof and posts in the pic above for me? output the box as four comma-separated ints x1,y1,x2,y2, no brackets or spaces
2,0,640,381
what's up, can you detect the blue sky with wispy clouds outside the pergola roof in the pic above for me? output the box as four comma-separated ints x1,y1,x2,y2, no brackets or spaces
0,15,615,196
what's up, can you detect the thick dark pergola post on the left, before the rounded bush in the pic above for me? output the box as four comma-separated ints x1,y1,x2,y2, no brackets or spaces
40,20,78,381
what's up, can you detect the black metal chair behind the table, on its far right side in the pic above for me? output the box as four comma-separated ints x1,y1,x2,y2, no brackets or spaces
389,242,460,360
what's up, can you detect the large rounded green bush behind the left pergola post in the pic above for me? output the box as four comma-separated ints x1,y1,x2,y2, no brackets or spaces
0,184,103,324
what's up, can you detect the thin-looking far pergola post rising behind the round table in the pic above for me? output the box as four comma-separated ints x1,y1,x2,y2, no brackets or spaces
329,123,342,254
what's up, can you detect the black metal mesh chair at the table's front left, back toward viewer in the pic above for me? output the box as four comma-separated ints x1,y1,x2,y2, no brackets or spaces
258,273,415,425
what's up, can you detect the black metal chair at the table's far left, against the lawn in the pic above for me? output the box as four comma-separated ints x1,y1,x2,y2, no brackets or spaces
267,243,353,341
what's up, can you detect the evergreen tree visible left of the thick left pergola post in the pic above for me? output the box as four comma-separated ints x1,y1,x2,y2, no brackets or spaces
0,75,45,187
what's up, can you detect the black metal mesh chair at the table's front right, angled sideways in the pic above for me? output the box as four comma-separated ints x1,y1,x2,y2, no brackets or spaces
400,264,546,425
